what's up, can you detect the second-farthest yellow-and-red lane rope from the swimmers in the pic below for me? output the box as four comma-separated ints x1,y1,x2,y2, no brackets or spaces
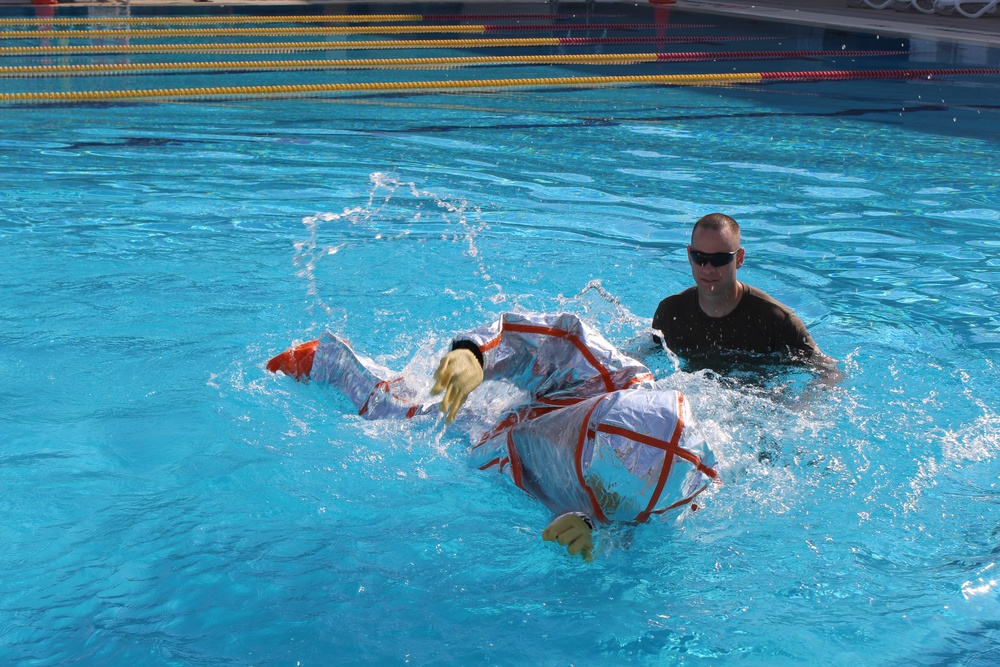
0,23,712,39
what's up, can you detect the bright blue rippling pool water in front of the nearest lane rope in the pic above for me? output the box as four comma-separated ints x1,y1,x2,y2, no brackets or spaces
0,2,1000,665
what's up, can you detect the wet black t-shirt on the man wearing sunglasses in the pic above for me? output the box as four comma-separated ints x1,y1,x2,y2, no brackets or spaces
653,283,819,357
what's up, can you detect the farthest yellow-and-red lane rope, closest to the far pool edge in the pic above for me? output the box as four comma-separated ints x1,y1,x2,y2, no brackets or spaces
0,14,627,26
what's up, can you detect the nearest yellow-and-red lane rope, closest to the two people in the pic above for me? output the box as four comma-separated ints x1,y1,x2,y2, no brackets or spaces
0,67,1000,103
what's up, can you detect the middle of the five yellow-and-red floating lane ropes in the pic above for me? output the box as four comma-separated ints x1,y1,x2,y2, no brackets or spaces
0,36,783,57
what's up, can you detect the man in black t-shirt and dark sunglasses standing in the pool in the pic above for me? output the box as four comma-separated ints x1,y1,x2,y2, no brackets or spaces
653,213,827,361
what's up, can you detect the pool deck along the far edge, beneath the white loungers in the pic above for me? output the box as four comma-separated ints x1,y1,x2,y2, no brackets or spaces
0,0,1000,48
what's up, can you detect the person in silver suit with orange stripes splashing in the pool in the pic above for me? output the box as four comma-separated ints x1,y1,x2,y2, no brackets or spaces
267,313,716,560
